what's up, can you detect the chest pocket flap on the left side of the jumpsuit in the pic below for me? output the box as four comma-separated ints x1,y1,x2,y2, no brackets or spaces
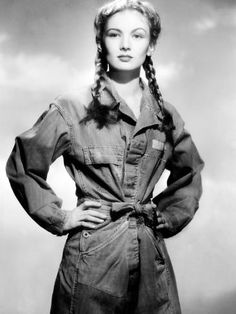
83,146,124,166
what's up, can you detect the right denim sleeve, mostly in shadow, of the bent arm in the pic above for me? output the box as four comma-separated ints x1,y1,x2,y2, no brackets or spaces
153,103,204,238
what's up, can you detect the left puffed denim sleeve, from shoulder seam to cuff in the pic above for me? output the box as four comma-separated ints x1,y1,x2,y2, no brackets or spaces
6,105,71,235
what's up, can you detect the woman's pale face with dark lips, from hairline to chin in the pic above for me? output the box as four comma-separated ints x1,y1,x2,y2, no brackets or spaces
103,10,153,71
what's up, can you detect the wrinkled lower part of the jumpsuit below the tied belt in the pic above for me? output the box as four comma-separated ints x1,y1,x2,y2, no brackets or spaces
51,217,181,314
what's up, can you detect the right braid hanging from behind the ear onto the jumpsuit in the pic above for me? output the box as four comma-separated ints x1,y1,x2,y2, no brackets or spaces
143,56,174,135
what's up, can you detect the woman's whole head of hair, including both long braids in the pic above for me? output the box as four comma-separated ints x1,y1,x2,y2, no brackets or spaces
84,0,173,130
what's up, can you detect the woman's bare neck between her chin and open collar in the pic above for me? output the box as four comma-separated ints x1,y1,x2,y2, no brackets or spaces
108,69,140,97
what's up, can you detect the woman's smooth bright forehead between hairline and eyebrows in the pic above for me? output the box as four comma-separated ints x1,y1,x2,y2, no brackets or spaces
106,9,149,30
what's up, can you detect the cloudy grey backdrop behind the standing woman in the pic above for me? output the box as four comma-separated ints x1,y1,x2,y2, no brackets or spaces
0,0,236,314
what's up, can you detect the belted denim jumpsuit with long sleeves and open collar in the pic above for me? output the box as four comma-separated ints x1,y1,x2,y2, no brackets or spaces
6,76,203,314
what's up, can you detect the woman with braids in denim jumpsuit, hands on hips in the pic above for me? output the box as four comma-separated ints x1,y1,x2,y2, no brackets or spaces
7,0,203,314
